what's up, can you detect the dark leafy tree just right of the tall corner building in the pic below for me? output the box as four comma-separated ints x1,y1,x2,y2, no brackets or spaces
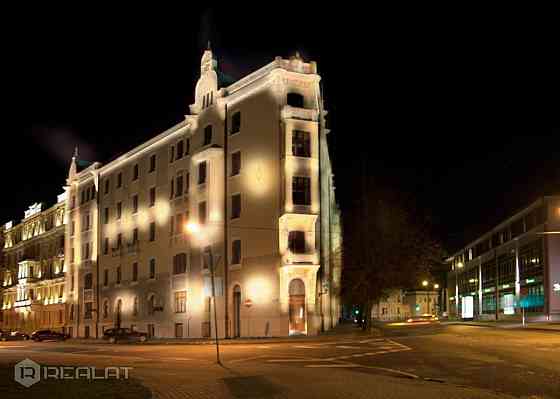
342,167,442,328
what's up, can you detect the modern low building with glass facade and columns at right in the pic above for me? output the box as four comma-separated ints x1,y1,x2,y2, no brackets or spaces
447,196,560,320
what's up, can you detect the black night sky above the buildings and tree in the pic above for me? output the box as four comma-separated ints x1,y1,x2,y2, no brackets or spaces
0,7,560,253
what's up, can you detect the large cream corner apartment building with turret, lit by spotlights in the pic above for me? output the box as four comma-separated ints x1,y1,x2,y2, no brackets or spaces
61,50,341,337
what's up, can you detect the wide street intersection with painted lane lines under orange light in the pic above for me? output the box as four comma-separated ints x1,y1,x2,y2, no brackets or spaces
0,324,560,399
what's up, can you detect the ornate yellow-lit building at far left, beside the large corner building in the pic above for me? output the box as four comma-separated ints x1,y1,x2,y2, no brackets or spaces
0,198,68,333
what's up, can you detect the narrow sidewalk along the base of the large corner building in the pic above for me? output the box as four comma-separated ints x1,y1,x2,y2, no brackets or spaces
66,323,380,345
